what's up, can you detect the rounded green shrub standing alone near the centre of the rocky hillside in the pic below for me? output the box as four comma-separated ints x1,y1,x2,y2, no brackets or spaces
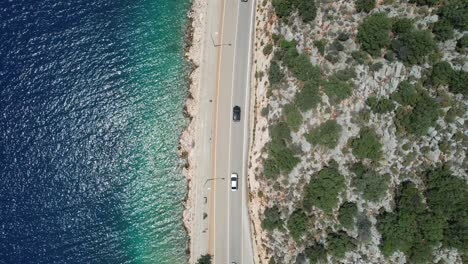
352,127,382,161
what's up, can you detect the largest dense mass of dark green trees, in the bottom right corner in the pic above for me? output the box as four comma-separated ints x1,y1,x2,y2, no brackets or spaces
377,167,468,263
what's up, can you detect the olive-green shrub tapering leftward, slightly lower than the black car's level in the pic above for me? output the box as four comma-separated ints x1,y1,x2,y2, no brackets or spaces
305,120,342,149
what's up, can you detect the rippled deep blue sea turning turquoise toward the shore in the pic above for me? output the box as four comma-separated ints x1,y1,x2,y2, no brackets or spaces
0,0,190,263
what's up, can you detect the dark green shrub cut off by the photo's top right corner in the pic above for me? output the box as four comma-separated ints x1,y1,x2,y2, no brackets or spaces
438,0,468,31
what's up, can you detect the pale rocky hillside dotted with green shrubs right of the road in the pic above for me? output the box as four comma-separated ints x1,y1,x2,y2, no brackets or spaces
249,0,468,263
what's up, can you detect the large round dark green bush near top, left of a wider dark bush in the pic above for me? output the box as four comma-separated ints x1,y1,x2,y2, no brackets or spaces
357,13,391,57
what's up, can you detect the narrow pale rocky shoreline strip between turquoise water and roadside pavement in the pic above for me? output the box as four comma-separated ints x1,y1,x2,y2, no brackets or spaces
178,0,207,259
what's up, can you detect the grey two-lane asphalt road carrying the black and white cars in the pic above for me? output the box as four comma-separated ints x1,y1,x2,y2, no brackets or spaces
210,0,255,264
